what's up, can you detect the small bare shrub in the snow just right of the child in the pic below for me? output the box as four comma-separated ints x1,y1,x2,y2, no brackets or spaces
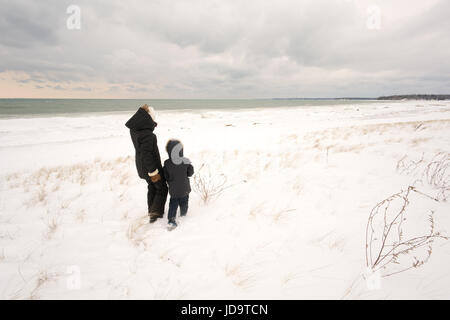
193,164,227,204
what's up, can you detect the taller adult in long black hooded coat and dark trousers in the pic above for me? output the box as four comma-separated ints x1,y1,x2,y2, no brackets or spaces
125,105,168,223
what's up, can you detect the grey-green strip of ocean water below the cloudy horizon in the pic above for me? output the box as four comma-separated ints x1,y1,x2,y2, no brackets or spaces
0,99,380,118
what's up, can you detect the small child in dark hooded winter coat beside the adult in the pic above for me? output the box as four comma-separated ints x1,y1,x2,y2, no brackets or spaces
163,140,194,228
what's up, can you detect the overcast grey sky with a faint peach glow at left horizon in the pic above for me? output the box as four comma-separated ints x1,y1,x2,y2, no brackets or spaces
0,0,450,98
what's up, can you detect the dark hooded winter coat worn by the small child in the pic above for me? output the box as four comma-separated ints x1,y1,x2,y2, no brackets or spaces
164,144,194,198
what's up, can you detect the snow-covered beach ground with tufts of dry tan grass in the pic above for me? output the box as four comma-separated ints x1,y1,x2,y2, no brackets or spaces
0,101,450,299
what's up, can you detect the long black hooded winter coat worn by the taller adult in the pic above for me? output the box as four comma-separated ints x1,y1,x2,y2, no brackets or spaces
125,108,162,180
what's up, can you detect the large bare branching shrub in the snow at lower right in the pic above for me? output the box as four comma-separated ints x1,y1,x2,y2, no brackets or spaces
366,186,448,277
